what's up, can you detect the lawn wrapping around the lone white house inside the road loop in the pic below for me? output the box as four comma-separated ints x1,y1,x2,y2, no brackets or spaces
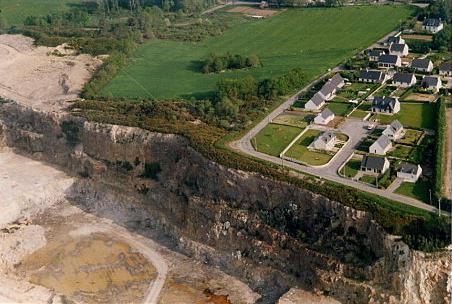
285,130,334,166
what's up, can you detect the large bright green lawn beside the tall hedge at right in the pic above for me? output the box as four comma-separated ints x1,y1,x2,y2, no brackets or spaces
375,102,436,129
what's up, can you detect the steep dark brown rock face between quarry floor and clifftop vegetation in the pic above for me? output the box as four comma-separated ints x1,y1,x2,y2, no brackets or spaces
0,103,452,303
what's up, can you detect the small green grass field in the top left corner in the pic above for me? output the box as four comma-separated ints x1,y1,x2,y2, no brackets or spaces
0,0,81,25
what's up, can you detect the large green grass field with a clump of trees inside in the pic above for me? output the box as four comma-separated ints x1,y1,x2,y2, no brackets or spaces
100,6,412,98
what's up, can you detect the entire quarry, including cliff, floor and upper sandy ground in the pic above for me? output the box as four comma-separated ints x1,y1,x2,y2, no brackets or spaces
0,35,452,304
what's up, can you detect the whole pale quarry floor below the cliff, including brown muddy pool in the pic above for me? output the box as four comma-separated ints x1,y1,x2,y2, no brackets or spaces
0,149,259,304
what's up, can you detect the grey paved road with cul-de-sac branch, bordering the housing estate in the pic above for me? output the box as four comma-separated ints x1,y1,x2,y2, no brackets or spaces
230,32,446,213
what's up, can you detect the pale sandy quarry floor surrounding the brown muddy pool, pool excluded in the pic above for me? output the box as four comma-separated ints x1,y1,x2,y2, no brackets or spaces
0,148,259,304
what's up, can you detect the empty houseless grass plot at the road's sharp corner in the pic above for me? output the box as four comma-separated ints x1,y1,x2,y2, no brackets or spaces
251,123,303,156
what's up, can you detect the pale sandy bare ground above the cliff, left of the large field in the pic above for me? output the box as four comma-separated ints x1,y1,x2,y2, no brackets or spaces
0,35,101,110
